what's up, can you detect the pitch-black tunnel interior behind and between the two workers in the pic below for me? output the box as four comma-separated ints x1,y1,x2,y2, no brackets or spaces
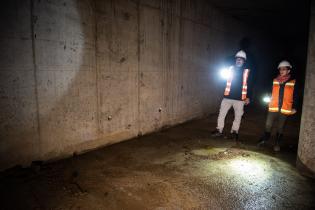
212,0,311,108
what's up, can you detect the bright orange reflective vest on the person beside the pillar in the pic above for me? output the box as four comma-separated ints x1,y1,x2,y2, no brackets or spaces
269,79,295,115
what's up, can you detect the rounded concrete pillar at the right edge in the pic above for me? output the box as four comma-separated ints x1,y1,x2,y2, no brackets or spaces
298,1,315,177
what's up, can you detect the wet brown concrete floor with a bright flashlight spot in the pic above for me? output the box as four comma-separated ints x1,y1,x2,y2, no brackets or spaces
0,109,315,209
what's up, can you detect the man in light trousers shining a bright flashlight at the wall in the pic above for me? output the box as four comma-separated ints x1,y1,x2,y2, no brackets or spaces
212,50,250,142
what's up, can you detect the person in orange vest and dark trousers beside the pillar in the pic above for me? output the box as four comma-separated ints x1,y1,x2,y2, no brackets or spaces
258,60,297,152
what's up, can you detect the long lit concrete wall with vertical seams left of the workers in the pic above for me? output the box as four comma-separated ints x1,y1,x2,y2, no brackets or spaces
0,0,272,169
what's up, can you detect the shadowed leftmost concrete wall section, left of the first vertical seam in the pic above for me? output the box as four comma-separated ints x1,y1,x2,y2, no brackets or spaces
0,0,43,169
